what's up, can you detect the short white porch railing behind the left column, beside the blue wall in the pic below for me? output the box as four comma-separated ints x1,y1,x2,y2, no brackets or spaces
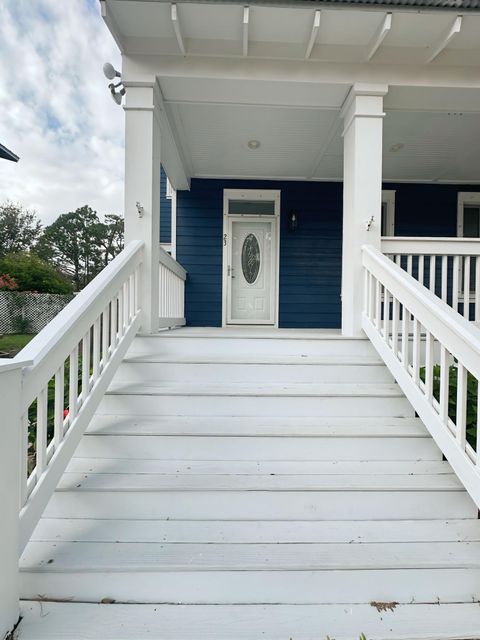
159,242,187,328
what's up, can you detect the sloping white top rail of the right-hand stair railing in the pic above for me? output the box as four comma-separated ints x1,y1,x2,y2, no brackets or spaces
362,245,480,379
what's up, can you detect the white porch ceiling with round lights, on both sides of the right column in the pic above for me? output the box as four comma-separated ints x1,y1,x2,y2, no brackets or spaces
160,78,480,183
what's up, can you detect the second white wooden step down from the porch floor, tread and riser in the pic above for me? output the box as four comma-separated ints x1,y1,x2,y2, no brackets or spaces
97,390,413,417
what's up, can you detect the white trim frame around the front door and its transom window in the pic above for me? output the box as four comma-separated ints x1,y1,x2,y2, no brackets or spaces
222,189,281,328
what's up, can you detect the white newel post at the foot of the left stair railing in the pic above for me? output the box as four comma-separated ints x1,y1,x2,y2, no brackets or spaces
0,359,26,638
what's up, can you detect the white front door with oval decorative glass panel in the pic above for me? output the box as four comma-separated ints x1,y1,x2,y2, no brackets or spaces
227,216,276,325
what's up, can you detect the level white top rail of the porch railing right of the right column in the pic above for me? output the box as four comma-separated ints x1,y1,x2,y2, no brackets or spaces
381,236,480,256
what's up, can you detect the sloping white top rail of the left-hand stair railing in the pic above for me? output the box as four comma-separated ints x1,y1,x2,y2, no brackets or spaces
13,241,143,392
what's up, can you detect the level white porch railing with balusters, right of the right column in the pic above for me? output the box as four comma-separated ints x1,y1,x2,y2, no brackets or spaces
382,237,480,322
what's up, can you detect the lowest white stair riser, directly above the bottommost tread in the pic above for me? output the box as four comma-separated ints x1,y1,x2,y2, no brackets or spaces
20,568,480,607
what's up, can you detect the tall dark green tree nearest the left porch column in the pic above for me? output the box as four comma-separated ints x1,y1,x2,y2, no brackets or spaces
36,205,103,291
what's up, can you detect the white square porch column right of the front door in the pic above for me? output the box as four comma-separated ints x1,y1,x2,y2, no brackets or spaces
341,84,388,336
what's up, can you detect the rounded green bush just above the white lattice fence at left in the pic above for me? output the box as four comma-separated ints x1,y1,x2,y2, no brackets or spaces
0,253,73,293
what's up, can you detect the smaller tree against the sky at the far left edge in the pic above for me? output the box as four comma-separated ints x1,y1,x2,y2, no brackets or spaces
0,200,42,258
